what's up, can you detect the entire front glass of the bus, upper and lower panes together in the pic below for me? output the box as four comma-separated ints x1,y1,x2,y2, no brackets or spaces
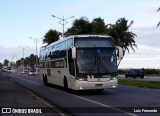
75,37,117,74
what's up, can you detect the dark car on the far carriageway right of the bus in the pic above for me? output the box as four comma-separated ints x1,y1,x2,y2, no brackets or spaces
125,69,144,79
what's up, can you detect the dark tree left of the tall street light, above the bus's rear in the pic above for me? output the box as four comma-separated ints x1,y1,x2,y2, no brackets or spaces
43,29,61,45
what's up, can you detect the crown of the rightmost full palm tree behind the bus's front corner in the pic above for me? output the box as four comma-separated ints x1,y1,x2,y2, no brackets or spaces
108,18,137,53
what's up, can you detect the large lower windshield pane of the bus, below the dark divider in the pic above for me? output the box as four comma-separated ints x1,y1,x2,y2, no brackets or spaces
77,48,117,74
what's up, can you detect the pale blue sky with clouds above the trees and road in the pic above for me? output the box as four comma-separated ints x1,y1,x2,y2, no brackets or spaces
0,0,160,69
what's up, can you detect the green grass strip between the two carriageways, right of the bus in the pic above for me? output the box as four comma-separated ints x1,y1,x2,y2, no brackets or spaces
118,79,160,89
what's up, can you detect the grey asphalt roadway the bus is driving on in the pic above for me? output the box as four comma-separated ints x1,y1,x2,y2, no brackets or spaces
2,73,160,116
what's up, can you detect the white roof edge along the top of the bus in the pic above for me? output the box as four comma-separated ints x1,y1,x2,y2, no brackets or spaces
40,34,112,50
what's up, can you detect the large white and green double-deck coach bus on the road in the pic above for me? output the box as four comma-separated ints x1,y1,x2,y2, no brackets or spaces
39,35,123,91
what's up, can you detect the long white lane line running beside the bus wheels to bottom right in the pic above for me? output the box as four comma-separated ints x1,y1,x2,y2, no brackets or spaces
12,77,138,116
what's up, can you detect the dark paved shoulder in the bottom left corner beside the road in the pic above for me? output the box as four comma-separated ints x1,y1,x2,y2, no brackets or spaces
0,75,65,116
